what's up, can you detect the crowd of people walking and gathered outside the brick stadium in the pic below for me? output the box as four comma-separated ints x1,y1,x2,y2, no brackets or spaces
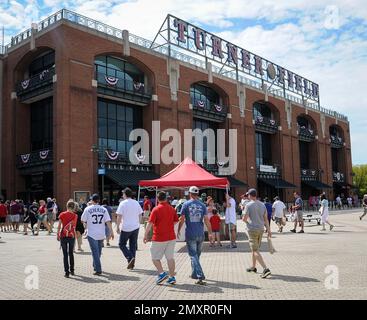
0,186,367,285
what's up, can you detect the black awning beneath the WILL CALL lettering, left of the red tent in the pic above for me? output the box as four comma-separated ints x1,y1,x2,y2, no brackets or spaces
106,169,159,187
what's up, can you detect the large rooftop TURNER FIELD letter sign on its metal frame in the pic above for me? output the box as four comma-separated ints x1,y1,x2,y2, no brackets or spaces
168,15,319,101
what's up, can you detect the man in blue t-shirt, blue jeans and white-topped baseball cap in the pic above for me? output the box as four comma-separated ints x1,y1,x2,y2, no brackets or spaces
177,186,212,285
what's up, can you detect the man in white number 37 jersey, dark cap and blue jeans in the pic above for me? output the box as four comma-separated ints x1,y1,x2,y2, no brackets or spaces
81,194,114,276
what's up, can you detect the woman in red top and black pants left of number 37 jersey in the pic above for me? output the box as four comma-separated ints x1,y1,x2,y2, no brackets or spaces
57,200,78,278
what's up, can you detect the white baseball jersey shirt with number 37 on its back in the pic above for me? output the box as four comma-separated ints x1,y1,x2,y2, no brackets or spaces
81,204,111,240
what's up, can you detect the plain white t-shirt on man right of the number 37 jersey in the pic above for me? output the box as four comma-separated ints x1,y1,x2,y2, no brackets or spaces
116,198,143,232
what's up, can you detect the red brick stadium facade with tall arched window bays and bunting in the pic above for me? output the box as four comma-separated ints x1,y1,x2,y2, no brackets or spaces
0,10,352,203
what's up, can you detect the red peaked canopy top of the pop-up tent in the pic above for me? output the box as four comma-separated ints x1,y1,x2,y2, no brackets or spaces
139,157,229,189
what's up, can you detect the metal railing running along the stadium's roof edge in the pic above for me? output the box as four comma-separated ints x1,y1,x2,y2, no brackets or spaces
4,9,348,121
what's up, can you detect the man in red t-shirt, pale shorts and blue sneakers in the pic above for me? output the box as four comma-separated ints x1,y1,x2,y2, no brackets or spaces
144,192,178,284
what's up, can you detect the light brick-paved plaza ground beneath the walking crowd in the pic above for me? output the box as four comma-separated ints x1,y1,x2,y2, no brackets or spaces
0,210,367,301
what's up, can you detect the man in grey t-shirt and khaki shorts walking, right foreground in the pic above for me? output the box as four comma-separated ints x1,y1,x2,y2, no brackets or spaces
242,189,271,279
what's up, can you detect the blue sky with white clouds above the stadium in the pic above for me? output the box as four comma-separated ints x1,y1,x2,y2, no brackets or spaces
0,0,367,164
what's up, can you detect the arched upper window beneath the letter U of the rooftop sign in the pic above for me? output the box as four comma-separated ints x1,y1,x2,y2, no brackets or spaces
190,83,220,110
